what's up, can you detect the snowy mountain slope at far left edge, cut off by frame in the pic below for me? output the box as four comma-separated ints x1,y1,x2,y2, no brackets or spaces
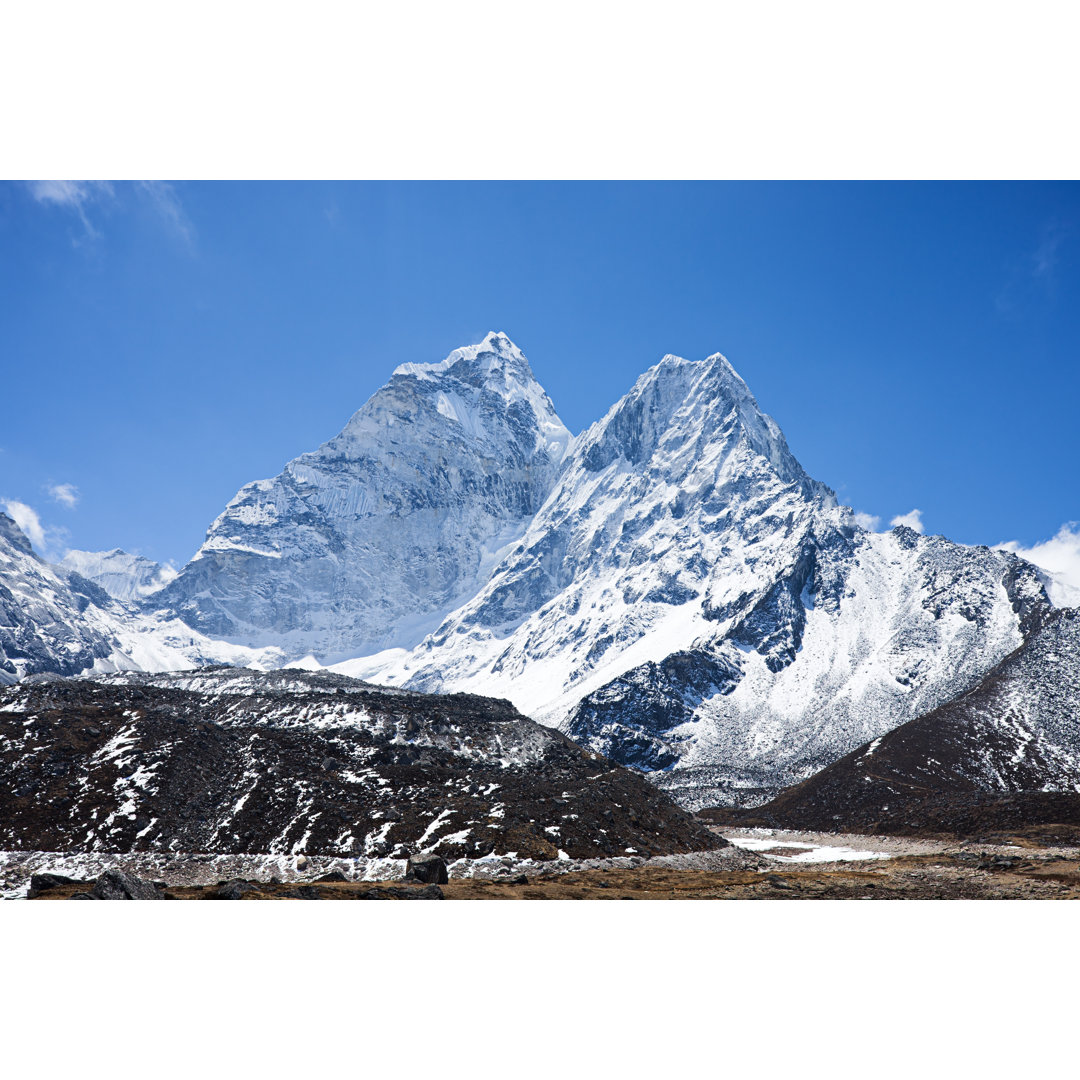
0,513,282,684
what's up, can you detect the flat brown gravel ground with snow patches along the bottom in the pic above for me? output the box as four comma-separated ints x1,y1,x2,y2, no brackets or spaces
10,829,1080,900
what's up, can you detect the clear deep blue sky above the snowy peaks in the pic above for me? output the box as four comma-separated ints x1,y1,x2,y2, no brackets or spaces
0,183,1080,564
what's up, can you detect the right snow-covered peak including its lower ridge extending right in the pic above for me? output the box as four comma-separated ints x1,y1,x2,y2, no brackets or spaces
338,345,1049,805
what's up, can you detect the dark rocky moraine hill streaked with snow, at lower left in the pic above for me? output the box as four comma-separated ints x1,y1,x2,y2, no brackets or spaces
0,669,724,859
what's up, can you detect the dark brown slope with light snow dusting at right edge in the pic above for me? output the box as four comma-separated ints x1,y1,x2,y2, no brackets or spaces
717,609,1080,833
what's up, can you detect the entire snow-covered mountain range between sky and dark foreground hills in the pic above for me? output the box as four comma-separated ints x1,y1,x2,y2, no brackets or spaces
0,334,1064,808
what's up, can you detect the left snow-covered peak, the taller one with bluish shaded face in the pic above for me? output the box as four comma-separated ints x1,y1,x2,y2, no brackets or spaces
152,334,570,663
